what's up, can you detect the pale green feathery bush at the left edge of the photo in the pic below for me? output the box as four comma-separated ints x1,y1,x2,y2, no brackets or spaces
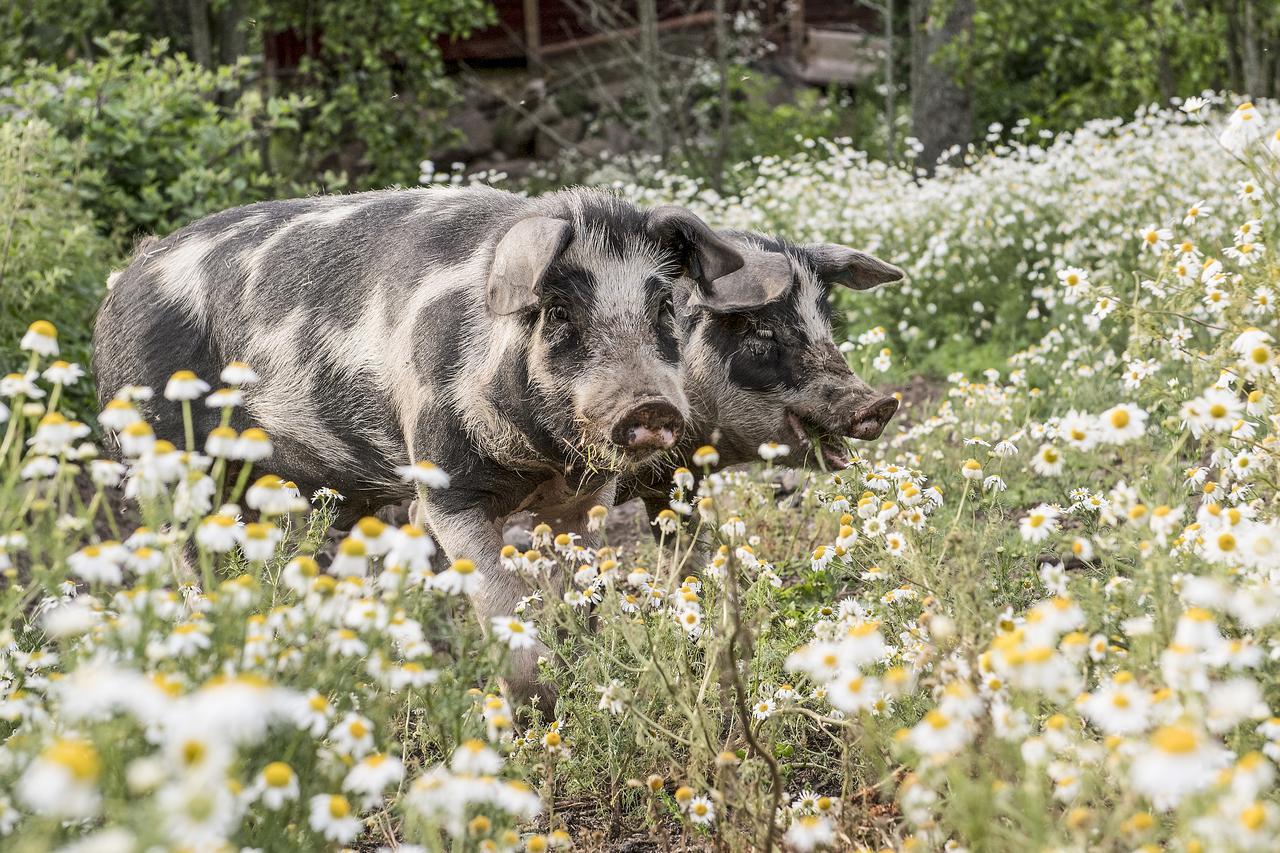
0,119,115,414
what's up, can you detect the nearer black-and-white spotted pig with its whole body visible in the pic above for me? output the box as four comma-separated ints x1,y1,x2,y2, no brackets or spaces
93,187,768,712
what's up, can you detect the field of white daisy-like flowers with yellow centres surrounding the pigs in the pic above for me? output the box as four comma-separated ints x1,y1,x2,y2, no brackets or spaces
0,99,1280,852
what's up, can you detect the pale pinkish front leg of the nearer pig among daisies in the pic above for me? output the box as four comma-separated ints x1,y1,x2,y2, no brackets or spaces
415,488,558,719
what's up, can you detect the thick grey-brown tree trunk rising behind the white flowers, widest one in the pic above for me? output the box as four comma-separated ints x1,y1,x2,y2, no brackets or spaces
911,0,974,174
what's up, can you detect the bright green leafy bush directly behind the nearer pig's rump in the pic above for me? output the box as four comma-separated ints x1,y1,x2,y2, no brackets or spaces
0,33,306,246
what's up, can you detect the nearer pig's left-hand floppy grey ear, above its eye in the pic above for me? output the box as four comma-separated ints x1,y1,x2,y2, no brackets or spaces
485,216,573,316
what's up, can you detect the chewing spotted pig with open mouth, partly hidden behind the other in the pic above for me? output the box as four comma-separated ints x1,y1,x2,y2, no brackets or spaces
617,231,902,522
